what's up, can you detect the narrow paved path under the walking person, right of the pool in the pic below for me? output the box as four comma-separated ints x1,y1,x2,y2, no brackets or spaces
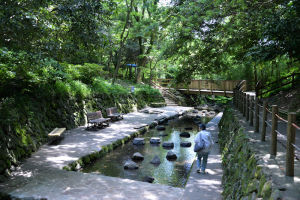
182,113,223,200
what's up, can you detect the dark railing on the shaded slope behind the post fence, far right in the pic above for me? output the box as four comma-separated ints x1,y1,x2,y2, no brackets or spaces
255,72,300,98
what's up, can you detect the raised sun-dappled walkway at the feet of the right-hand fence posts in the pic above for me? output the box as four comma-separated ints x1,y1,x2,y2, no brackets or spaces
235,106,300,200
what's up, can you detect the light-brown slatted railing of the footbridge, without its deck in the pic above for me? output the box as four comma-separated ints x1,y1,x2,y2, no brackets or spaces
156,79,246,91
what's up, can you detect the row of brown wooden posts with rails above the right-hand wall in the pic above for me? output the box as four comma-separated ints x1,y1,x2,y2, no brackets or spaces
233,88,300,176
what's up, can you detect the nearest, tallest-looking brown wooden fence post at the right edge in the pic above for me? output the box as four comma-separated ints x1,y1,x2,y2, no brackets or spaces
285,112,296,176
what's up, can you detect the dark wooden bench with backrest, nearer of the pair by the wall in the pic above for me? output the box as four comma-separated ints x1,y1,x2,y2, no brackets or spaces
87,110,110,129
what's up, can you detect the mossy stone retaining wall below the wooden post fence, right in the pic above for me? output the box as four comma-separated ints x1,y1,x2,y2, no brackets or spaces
219,109,274,200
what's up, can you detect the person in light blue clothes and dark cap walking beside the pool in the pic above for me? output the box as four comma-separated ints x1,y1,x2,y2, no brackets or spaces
195,124,214,174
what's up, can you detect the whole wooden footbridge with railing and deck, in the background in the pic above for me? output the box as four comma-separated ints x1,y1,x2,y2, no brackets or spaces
156,79,247,97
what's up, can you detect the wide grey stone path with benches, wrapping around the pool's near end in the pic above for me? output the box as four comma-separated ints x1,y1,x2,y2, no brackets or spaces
0,106,192,200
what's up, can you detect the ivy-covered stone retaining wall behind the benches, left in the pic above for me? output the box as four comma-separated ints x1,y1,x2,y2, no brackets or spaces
0,92,162,181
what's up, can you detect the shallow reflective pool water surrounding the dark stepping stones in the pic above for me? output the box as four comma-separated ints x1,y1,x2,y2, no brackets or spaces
83,117,211,187
